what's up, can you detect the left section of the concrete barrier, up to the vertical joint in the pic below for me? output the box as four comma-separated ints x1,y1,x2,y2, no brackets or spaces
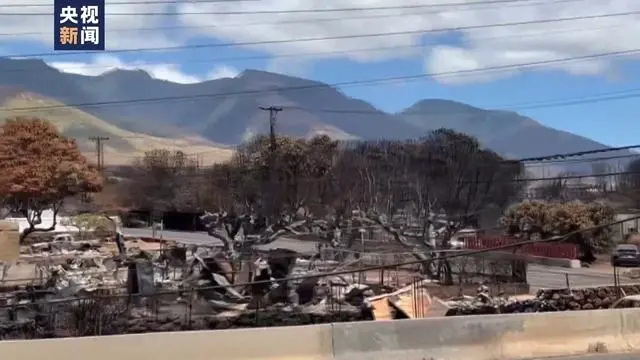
0,324,333,360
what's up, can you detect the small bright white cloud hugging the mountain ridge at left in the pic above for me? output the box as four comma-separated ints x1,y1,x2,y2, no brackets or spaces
49,55,239,84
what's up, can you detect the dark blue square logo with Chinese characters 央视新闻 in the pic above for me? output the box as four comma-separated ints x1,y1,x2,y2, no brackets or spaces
53,0,105,51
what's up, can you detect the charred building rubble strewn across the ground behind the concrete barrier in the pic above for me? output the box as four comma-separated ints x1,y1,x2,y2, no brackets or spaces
0,214,544,339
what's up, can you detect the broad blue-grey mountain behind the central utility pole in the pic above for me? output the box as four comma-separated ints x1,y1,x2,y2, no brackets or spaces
80,70,416,145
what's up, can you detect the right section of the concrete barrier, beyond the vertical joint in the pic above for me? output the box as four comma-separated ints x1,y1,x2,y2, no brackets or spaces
333,309,640,360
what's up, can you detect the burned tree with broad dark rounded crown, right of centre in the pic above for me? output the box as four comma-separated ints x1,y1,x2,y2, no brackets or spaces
330,129,521,279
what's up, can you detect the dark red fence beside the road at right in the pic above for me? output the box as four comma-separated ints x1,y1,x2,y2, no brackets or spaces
464,236,578,259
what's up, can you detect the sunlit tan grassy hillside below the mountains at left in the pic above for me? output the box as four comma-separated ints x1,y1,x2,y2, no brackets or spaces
0,88,232,165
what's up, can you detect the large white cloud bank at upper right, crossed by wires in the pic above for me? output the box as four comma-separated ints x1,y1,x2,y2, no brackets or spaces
179,0,640,83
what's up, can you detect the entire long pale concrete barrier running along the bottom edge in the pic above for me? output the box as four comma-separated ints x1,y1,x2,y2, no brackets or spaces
0,309,640,360
